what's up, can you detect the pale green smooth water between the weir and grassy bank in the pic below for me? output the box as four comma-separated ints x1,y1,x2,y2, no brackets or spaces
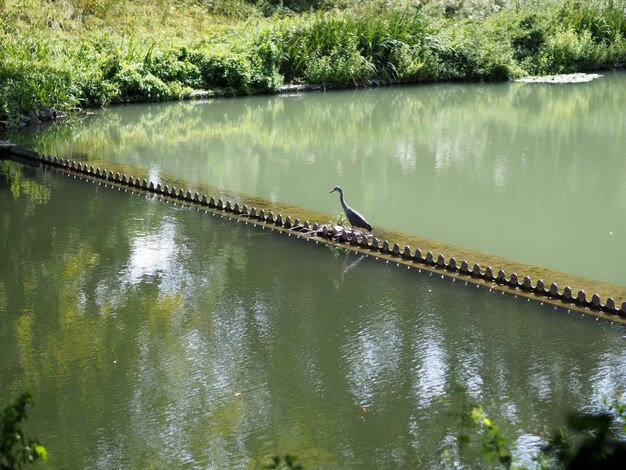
2,73,626,286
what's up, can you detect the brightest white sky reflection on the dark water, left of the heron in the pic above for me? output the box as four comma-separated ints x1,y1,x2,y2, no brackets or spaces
128,222,178,284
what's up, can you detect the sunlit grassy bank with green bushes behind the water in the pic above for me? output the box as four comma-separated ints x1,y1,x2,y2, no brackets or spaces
0,0,626,126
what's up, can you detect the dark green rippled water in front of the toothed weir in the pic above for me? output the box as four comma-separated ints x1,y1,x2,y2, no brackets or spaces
0,163,626,469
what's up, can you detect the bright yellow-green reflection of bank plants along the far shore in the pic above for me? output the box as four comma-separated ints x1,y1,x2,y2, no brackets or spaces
11,75,623,163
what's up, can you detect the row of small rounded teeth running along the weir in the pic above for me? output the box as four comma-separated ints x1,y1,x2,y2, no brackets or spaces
33,155,626,316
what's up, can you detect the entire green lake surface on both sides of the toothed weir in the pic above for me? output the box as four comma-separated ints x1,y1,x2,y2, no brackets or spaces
0,74,626,469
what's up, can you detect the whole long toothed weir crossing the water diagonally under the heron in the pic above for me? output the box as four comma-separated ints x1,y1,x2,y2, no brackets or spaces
0,142,626,324
